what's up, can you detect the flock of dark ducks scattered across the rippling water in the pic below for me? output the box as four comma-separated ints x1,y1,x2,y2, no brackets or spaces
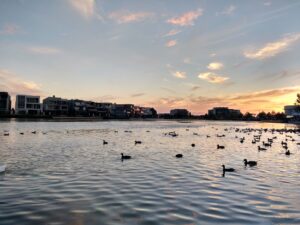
0,127,300,176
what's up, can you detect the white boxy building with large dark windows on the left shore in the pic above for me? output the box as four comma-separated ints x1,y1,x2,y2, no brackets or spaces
16,95,42,115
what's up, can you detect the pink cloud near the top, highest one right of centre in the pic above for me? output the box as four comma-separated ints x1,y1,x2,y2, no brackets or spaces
167,9,203,26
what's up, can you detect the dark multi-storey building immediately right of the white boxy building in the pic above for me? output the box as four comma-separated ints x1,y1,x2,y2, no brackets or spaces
43,96,69,116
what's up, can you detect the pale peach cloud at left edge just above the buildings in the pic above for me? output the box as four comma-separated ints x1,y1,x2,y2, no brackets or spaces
0,69,45,99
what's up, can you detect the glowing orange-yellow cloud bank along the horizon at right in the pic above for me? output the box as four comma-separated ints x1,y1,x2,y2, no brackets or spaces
149,86,300,114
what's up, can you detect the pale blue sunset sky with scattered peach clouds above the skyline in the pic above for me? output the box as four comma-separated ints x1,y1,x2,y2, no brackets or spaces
0,0,300,114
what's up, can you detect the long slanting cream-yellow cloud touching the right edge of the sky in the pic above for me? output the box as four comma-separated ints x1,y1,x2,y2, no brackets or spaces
244,33,300,59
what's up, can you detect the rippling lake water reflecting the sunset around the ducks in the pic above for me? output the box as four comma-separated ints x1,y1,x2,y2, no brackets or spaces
0,121,300,225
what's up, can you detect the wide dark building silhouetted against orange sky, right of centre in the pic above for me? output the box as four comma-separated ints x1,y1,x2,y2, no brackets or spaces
208,107,243,119
